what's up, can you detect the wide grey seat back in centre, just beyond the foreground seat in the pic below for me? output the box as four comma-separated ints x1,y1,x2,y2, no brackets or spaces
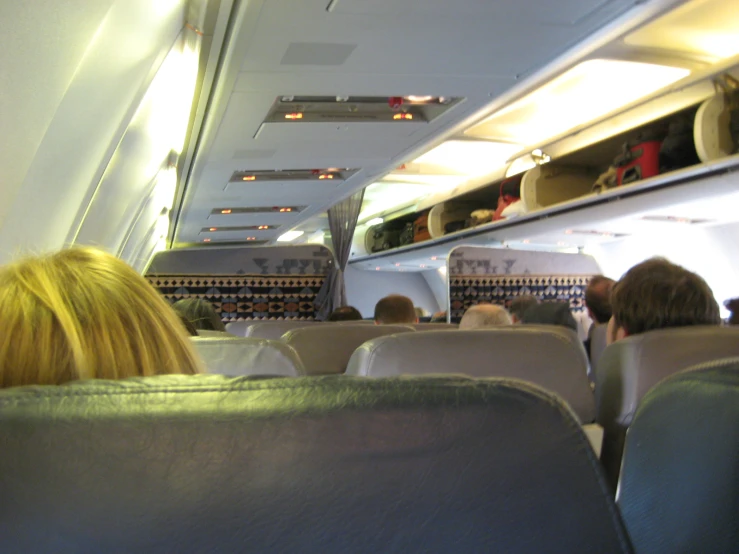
347,325,595,423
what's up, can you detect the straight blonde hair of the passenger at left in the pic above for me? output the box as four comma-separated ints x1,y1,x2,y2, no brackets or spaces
0,248,200,387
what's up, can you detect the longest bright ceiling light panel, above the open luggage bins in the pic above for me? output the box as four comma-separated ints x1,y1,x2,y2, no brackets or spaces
467,60,690,146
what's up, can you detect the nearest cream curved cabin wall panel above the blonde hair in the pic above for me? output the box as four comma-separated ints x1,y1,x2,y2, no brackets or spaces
0,0,186,263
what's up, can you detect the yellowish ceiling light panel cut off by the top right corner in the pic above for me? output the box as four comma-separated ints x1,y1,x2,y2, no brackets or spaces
624,0,739,60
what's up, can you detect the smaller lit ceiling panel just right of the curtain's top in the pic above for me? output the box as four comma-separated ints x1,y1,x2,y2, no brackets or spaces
415,140,521,177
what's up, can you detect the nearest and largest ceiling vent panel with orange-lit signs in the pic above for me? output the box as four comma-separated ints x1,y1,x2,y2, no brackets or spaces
264,96,462,123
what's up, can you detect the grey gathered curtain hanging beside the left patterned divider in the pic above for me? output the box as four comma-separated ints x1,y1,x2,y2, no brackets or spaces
316,190,364,320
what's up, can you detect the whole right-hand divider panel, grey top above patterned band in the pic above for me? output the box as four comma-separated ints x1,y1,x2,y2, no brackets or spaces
448,246,599,323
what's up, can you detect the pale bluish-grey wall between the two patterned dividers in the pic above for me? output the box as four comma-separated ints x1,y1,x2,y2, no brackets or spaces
344,266,444,318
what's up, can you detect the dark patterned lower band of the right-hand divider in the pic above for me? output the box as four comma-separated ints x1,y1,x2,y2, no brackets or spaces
449,275,591,323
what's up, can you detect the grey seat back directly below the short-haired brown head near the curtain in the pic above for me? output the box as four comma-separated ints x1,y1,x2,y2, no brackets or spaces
280,325,414,375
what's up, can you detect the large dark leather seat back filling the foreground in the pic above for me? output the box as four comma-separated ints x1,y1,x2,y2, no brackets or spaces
0,375,632,554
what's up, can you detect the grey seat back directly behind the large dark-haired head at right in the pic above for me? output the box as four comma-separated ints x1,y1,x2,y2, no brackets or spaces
595,326,739,488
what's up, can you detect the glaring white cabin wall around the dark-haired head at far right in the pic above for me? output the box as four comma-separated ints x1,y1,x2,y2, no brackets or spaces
588,223,739,316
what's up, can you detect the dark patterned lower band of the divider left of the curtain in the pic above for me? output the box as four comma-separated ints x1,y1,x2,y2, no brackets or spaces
147,274,326,323
